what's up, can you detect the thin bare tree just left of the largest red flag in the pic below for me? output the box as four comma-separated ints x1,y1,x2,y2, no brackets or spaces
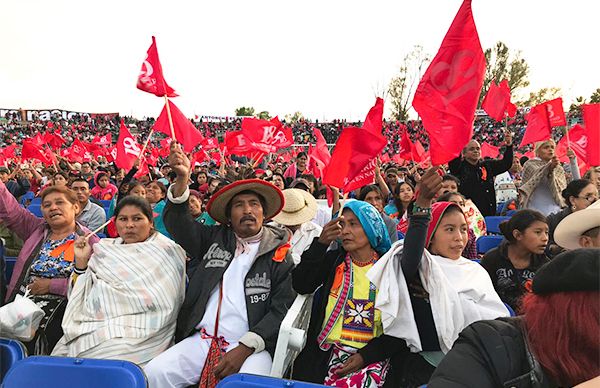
388,46,431,121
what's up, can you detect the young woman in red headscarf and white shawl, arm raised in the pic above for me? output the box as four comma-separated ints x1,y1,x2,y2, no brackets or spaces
367,169,509,387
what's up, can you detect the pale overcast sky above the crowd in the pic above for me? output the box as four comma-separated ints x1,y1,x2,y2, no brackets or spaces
0,0,600,119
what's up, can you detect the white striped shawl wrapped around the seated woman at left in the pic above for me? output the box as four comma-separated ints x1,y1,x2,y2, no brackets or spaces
62,233,186,355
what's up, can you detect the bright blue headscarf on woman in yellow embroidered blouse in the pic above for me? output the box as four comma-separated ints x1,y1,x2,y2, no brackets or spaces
344,201,392,256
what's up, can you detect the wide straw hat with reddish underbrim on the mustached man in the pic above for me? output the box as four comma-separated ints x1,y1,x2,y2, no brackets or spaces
206,179,284,224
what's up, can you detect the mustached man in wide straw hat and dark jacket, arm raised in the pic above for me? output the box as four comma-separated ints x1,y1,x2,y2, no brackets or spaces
145,142,296,387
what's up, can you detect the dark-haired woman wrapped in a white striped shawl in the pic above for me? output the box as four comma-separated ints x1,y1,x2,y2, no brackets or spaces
52,196,186,367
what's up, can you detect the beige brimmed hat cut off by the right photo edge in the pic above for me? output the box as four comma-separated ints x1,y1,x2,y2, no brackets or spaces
554,201,600,249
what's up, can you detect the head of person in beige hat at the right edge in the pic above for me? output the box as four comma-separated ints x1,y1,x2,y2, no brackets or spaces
554,200,600,249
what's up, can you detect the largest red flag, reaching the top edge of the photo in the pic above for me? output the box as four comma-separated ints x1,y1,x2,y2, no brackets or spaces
413,0,485,165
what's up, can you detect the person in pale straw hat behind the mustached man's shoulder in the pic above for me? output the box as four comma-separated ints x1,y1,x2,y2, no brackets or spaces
273,189,323,265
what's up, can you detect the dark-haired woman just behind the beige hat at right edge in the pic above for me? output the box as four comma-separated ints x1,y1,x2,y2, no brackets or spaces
547,179,598,256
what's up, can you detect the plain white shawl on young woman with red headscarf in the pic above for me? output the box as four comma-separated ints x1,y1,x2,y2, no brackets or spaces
367,240,509,353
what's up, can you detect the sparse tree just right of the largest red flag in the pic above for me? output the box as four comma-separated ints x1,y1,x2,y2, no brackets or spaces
479,42,529,106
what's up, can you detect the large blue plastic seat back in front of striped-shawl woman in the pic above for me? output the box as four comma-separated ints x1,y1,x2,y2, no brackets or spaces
3,356,148,388
